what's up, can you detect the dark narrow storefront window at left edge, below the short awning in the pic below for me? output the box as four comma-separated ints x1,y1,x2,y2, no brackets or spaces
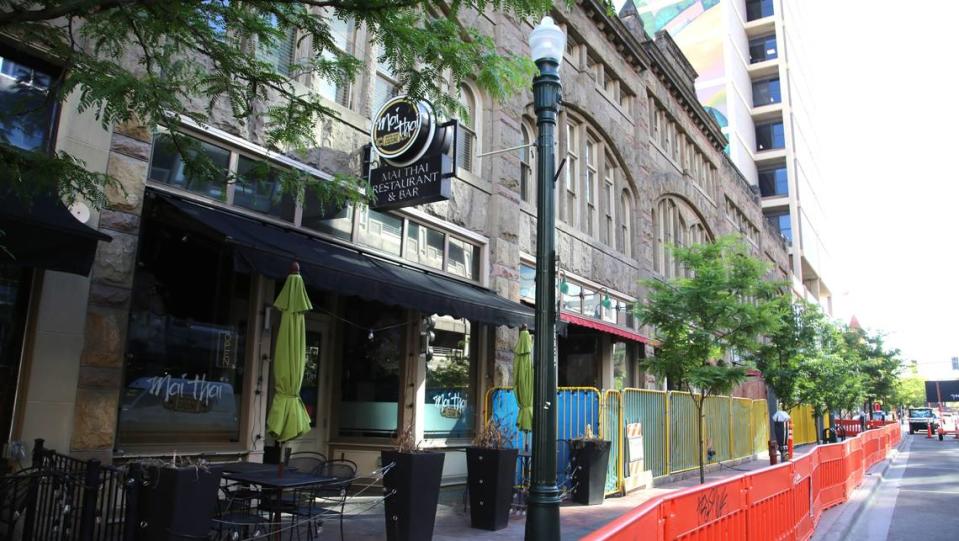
0,265,33,454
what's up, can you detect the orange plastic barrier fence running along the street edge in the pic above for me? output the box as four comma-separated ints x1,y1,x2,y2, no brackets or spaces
583,424,902,541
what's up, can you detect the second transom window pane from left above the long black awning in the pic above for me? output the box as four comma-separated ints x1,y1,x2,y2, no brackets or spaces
233,156,296,222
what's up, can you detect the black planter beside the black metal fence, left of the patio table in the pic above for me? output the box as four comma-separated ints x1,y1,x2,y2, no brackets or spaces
136,466,220,541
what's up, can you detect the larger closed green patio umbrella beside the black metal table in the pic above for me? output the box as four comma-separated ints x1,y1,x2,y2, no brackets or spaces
266,263,313,442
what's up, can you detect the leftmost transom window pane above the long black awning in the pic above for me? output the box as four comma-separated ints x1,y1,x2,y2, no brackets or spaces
150,133,230,201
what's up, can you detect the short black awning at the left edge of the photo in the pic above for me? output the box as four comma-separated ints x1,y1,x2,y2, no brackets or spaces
0,190,111,276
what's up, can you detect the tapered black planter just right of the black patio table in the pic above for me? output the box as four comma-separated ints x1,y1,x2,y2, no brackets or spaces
381,451,446,541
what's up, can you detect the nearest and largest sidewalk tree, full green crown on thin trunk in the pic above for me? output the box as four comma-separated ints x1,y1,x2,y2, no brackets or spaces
636,236,781,482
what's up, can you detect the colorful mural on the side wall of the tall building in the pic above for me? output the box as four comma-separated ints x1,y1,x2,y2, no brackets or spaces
636,0,729,128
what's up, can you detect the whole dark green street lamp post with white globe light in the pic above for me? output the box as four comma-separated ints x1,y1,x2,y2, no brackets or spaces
526,17,566,541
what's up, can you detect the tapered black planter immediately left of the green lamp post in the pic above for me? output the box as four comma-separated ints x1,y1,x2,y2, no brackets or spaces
466,447,519,530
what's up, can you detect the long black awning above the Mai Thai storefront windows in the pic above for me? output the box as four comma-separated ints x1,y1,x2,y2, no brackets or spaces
160,194,533,327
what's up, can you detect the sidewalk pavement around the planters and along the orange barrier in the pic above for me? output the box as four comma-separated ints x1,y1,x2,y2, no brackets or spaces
319,445,814,541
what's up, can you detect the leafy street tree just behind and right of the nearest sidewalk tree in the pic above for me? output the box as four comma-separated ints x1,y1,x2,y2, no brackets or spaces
749,295,830,411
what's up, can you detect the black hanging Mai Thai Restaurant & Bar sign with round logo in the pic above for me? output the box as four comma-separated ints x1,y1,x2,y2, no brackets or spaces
370,96,454,209
